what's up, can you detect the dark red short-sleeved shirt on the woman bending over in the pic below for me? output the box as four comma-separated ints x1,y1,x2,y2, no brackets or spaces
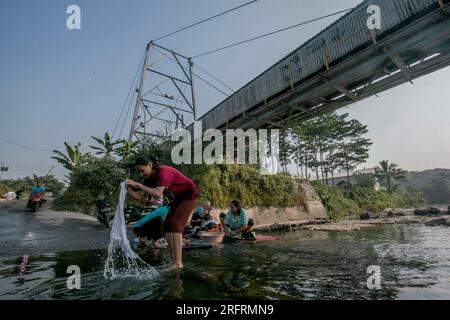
144,165,198,200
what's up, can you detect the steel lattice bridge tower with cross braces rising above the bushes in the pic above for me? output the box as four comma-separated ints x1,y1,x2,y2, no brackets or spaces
128,41,197,143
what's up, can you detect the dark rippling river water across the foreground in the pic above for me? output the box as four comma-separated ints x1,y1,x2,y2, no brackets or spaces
0,224,450,299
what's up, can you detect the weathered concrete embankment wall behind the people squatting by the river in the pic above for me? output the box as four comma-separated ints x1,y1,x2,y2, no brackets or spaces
207,180,327,227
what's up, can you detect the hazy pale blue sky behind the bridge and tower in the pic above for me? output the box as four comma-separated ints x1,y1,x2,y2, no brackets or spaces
0,0,450,178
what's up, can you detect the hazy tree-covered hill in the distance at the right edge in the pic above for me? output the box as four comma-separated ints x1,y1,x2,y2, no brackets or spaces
400,169,450,204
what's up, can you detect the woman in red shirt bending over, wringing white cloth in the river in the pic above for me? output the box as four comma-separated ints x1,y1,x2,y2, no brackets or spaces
126,156,198,270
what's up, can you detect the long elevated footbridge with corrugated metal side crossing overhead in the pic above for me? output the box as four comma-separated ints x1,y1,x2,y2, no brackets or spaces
189,0,450,132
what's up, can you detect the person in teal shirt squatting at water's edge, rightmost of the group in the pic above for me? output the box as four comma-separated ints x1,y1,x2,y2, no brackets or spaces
223,200,255,240
